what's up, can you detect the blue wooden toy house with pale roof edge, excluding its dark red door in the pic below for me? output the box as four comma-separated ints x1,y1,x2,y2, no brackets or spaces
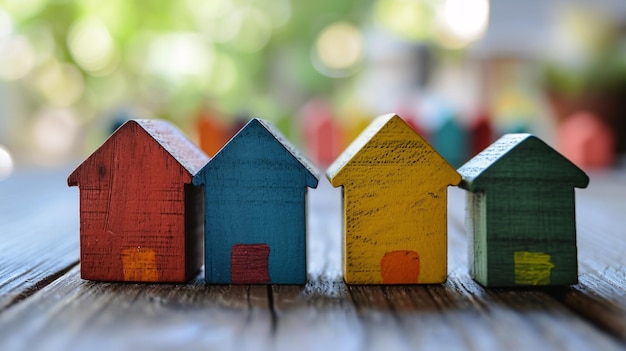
193,118,318,284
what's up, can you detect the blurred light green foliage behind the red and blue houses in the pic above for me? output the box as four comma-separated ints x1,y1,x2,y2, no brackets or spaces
0,0,371,124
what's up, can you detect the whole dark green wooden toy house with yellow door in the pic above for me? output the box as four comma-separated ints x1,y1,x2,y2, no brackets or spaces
459,134,589,287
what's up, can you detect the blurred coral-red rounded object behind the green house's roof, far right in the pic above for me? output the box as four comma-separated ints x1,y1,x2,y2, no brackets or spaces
557,111,616,169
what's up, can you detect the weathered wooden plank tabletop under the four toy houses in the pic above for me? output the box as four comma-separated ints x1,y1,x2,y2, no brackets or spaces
0,170,626,351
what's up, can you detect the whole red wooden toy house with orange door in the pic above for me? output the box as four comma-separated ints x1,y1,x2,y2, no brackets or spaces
68,120,208,282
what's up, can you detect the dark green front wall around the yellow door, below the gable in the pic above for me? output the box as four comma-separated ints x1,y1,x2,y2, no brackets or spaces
486,184,577,286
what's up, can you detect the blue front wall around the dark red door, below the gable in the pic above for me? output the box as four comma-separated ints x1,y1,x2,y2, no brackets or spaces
205,179,307,284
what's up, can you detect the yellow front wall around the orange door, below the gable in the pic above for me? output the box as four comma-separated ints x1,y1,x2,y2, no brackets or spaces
344,177,447,284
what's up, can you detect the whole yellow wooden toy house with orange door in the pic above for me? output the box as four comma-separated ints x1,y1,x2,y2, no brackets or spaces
326,115,461,284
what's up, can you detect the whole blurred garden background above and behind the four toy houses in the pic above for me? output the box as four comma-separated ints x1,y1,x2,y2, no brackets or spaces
0,0,626,174
